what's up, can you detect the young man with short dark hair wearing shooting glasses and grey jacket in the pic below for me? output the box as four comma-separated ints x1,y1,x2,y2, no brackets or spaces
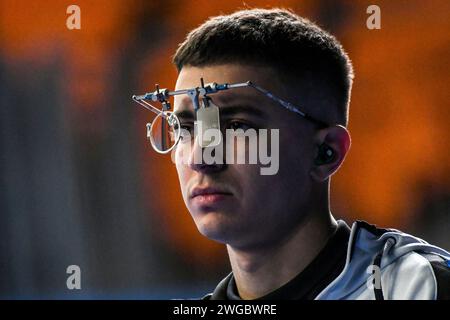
137,9,450,300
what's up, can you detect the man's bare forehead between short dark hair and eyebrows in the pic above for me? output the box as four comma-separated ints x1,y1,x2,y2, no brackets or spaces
174,64,280,110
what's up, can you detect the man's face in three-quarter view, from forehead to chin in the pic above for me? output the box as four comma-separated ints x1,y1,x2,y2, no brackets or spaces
174,64,315,247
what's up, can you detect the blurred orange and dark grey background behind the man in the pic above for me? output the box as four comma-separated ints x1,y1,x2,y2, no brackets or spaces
0,0,450,299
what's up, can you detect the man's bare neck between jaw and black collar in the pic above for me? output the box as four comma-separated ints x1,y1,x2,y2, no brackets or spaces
227,209,337,299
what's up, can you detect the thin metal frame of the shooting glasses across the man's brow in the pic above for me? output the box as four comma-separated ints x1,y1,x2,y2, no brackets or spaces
132,78,330,154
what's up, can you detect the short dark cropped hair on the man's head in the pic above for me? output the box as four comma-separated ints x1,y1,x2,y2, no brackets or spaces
173,9,353,125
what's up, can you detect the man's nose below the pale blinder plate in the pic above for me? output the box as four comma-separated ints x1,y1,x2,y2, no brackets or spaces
189,137,226,173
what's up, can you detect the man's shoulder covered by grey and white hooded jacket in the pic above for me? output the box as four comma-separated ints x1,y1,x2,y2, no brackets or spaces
317,221,450,300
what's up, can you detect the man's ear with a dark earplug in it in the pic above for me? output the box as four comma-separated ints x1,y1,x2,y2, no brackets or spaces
310,125,351,182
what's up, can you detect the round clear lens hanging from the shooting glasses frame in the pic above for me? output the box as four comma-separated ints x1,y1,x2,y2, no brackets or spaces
149,111,180,153
